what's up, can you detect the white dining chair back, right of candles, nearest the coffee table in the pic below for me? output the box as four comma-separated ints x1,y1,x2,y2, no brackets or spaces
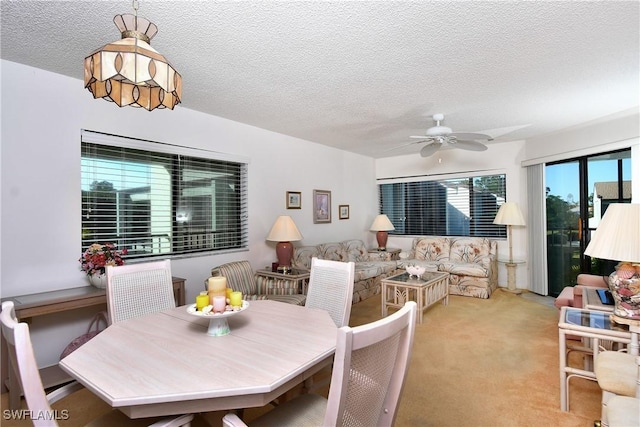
304,258,355,328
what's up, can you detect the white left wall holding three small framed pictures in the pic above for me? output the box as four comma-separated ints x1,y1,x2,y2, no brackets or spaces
0,61,377,366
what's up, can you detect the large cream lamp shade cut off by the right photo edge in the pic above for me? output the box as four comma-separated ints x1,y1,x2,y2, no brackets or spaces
584,203,640,262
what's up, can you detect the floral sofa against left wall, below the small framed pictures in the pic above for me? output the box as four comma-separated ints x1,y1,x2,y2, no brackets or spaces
293,239,398,304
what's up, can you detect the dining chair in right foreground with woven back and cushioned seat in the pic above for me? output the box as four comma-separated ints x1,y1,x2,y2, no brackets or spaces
222,301,416,427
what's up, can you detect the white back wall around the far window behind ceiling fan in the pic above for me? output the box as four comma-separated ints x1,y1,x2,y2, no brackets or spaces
376,141,528,289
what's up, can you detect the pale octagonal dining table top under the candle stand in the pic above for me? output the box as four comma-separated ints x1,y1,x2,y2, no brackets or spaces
60,301,337,418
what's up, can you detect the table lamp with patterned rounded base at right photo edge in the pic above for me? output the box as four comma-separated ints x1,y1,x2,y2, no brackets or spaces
584,203,640,320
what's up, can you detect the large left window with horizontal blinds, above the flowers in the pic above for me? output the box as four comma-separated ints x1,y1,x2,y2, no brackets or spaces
81,131,248,258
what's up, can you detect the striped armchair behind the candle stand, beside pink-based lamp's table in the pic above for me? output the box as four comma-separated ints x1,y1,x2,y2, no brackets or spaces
210,261,307,305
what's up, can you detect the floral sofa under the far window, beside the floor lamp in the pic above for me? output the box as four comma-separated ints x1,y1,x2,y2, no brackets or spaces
399,236,498,298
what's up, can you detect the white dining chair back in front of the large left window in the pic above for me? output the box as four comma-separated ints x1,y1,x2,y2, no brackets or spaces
106,260,176,324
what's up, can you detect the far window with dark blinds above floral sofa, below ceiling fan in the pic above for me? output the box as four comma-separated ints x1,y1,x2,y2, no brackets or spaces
378,174,506,238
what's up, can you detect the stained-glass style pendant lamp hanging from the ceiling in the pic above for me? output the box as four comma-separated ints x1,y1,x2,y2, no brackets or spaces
84,0,182,111
